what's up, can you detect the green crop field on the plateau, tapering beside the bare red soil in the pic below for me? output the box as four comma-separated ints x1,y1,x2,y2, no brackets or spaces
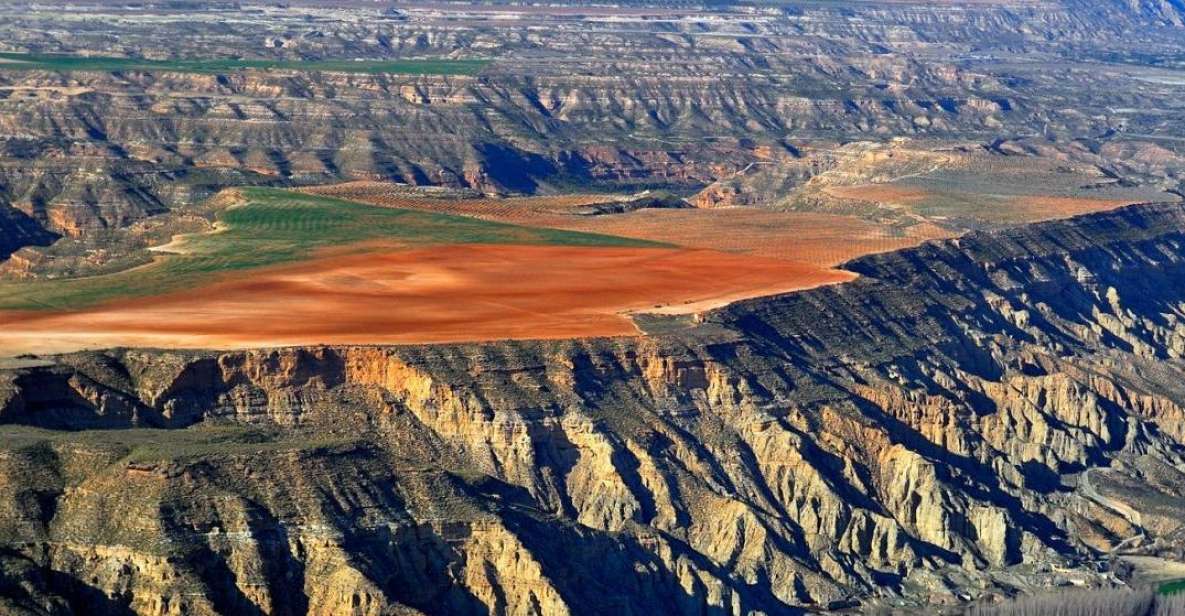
0,188,664,310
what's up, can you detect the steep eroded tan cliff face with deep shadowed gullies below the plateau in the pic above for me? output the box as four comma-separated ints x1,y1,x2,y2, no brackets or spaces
0,205,1185,614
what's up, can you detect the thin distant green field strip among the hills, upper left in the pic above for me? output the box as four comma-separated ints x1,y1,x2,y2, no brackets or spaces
0,53,489,75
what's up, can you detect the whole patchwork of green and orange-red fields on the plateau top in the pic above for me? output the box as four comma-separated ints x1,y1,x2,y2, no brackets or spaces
0,188,881,355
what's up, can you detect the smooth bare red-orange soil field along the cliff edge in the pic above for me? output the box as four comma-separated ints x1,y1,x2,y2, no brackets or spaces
0,244,853,354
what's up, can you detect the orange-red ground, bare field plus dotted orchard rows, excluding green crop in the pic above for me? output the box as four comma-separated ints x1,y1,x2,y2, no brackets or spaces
0,182,966,355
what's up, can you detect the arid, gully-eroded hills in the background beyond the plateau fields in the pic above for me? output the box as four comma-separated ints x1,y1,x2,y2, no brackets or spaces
0,0,1185,274
